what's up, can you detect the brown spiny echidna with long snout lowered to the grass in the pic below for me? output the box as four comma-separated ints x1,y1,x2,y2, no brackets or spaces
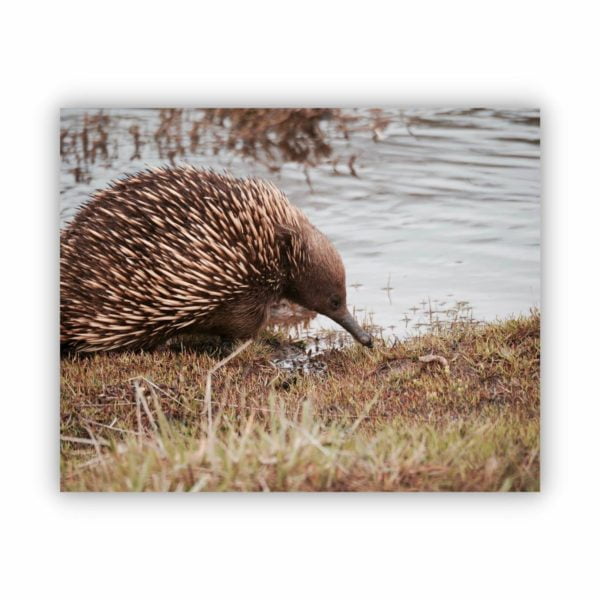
60,166,371,352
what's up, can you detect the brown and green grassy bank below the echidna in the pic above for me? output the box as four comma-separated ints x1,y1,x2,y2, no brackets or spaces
61,312,540,491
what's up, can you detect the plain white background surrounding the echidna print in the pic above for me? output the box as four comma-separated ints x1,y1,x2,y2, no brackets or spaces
0,0,600,599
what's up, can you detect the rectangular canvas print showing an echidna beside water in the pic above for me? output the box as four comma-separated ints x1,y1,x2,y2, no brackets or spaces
60,106,540,492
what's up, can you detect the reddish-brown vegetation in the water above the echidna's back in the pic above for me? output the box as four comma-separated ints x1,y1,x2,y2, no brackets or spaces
60,108,389,183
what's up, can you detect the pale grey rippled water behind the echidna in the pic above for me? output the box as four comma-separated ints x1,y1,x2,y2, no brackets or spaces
60,107,540,336
